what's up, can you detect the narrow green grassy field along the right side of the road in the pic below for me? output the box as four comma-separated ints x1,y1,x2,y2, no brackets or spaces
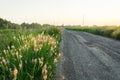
66,26,120,40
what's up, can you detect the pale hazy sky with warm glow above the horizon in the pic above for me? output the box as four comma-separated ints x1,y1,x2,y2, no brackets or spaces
0,0,120,25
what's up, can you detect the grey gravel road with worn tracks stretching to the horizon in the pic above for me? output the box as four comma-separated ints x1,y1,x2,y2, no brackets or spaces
57,29,120,80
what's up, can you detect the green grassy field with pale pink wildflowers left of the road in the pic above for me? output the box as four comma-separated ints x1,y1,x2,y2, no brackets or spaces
0,27,61,80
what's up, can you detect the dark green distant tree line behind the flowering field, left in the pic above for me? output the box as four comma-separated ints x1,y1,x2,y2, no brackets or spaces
0,18,54,29
